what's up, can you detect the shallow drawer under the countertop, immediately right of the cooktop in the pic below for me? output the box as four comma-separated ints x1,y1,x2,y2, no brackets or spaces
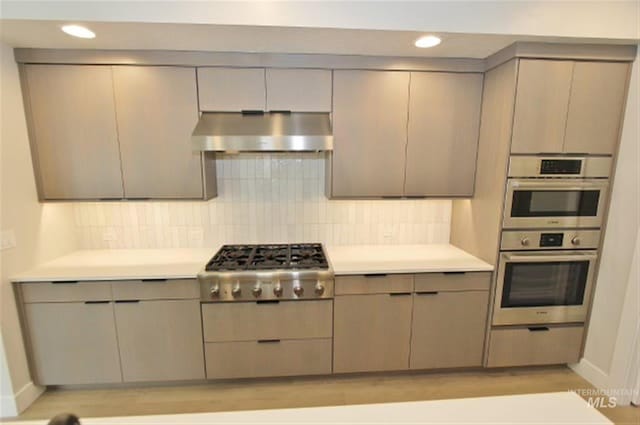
335,274,413,295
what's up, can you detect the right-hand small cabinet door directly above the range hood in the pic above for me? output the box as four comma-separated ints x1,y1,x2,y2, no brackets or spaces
267,68,331,112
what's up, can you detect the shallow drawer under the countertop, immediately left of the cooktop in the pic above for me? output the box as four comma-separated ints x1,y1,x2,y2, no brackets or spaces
112,279,200,300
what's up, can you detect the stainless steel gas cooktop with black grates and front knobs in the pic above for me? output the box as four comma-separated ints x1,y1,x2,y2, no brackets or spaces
198,244,334,302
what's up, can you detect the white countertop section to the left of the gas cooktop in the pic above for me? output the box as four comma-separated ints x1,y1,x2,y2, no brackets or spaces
11,247,218,282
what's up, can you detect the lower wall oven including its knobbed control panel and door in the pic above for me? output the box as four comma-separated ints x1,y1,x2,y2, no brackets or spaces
493,230,600,325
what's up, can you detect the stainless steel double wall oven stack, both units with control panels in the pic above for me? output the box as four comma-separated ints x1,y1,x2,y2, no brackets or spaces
493,156,611,325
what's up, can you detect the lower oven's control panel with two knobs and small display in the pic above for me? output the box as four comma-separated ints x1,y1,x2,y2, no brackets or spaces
500,230,600,251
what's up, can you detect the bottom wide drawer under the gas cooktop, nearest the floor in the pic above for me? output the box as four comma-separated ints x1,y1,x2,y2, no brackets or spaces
205,338,331,379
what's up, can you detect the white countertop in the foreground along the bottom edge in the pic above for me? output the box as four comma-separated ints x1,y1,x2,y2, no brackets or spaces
1,391,612,425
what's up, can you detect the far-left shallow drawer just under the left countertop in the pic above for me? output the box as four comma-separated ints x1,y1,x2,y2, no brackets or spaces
20,281,111,303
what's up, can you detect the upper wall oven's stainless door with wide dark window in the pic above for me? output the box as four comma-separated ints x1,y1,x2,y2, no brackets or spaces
503,179,608,229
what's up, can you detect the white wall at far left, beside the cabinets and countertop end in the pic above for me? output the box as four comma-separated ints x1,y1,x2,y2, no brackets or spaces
0,44,76,416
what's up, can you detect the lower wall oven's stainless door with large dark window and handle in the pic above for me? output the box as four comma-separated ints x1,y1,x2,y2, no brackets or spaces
493,251,597,325
